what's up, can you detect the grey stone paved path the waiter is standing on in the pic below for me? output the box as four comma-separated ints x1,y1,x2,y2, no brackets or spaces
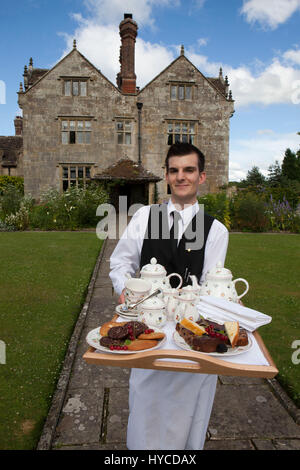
38,240,300,450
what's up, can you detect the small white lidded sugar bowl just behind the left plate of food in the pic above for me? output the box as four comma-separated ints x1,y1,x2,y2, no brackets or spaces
137,296,167,328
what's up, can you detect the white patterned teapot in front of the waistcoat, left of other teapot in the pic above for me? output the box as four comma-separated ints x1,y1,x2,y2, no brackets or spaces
140,258,182,298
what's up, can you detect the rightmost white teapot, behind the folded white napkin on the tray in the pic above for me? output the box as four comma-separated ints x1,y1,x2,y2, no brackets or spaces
200,262,249,302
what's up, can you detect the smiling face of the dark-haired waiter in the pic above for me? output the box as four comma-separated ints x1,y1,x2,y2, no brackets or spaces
166,153,206,204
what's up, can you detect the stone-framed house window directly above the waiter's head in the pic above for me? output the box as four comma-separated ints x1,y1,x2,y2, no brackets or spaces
165,118,198,145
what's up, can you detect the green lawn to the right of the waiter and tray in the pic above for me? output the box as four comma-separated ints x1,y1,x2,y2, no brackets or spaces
225,233,300,406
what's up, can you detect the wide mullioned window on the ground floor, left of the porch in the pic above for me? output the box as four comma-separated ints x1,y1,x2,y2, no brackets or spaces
59,162,94,192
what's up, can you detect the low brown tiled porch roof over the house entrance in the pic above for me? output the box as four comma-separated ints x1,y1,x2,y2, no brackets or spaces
93,158,161,182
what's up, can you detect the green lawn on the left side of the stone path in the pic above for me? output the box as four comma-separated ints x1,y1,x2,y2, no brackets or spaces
0,232,102,450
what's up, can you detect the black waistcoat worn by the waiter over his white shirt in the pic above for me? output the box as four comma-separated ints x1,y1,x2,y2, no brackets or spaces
140,204,214,287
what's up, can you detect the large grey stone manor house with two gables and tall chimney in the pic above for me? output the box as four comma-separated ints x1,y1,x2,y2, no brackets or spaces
0,14,234,205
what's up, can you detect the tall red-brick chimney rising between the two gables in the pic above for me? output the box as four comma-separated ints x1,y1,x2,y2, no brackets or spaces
117,13,138,93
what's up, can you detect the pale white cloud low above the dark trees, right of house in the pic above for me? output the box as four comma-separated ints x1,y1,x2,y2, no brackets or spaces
229,129,300,181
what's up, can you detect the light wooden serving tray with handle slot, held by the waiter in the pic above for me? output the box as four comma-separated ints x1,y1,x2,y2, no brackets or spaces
83,317,278,379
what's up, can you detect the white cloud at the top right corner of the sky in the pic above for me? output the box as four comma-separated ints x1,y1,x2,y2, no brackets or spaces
241,0,300,29
